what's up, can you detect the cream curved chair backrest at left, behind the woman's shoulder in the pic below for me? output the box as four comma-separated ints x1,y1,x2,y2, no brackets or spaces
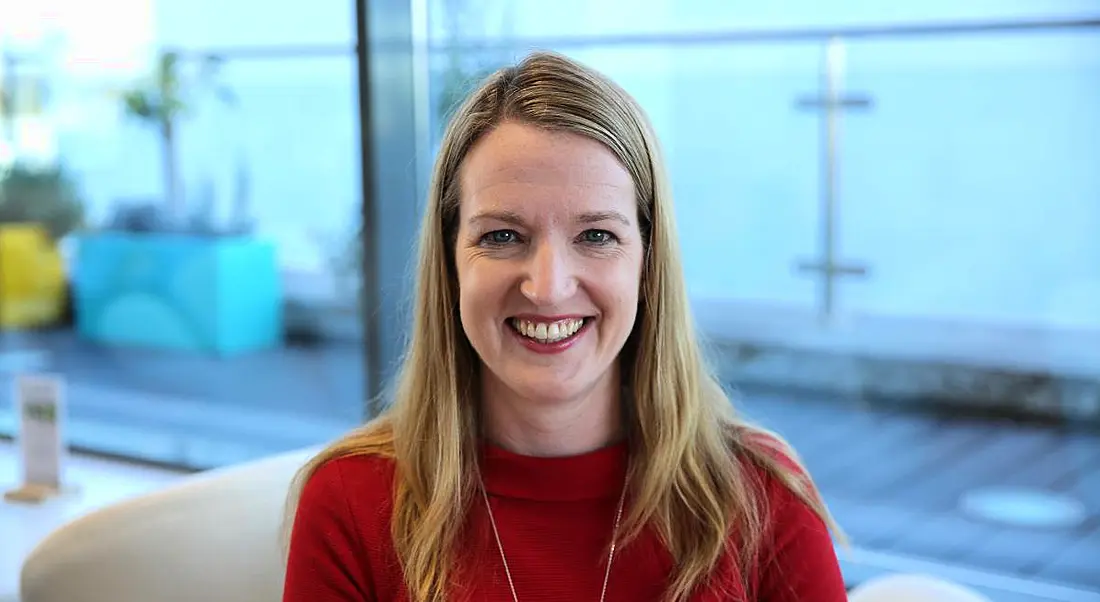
20,449,317,602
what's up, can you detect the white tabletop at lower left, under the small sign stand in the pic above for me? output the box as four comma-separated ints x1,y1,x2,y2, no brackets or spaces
0,441,186,602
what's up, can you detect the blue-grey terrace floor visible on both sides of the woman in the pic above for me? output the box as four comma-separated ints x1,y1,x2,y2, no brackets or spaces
0,332,1100,601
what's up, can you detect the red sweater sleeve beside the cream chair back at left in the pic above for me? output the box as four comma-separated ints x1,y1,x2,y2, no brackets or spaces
283,460,375,602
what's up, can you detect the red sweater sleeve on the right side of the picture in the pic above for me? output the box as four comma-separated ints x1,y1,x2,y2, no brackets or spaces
757,471,848,602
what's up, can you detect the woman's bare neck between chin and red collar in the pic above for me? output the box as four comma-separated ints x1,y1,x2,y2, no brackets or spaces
482,371,623,458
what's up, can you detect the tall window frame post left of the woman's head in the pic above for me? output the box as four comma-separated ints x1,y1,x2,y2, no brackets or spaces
355,0,420,418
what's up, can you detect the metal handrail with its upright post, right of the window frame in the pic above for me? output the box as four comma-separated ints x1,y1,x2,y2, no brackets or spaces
428,15,1100,327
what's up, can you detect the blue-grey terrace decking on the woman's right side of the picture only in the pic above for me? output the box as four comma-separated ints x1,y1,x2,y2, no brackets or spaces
740,395,1100,599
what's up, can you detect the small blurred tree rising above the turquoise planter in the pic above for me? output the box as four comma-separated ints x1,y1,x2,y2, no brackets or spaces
122,52,237,215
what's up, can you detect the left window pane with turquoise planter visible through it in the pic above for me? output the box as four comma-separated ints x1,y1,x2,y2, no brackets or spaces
0,0,365,468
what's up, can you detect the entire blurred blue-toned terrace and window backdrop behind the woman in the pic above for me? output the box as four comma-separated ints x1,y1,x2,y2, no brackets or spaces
0,0,1100,600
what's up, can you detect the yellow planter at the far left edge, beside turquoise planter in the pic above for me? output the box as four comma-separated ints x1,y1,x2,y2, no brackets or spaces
0,223,66,329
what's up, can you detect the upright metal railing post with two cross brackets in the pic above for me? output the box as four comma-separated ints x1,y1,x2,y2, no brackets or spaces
798,37,871,322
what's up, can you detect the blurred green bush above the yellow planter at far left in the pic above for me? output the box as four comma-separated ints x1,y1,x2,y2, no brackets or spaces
0,164,84,240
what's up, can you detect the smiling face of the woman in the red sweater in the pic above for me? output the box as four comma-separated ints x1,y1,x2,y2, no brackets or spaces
455,122,644,403
